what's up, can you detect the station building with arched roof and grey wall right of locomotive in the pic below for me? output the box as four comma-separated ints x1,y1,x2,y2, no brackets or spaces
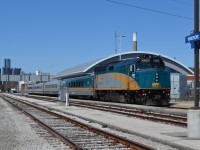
53,51,194,98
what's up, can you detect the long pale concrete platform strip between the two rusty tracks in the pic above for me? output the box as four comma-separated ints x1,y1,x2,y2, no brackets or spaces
4,94,200,150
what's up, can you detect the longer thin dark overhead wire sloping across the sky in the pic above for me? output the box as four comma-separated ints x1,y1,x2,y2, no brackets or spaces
105,0,194,20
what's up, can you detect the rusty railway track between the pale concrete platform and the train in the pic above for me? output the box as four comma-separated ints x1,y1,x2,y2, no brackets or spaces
21,95,187,127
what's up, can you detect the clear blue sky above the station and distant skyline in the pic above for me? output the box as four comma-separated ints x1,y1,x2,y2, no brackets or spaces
0,0,194,74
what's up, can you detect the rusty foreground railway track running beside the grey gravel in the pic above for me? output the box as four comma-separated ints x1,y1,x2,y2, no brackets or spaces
1,95,153,150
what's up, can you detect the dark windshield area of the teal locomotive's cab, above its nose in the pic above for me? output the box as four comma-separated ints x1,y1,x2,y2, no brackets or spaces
136,55,165,70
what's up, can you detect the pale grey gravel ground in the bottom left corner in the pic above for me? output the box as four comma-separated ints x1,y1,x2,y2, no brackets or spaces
0,98,68,150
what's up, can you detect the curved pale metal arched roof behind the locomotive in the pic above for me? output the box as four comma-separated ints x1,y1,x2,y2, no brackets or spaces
54,51,194,80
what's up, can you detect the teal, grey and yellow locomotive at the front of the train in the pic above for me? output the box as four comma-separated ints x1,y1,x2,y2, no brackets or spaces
94,55,170,105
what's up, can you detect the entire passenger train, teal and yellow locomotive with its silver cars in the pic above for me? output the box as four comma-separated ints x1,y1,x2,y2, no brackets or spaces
27,55,170,105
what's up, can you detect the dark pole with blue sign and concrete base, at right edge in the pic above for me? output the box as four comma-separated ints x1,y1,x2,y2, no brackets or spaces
185,0,200,138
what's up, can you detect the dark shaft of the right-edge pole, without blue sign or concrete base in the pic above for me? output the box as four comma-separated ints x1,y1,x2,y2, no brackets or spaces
194,0,199,108
